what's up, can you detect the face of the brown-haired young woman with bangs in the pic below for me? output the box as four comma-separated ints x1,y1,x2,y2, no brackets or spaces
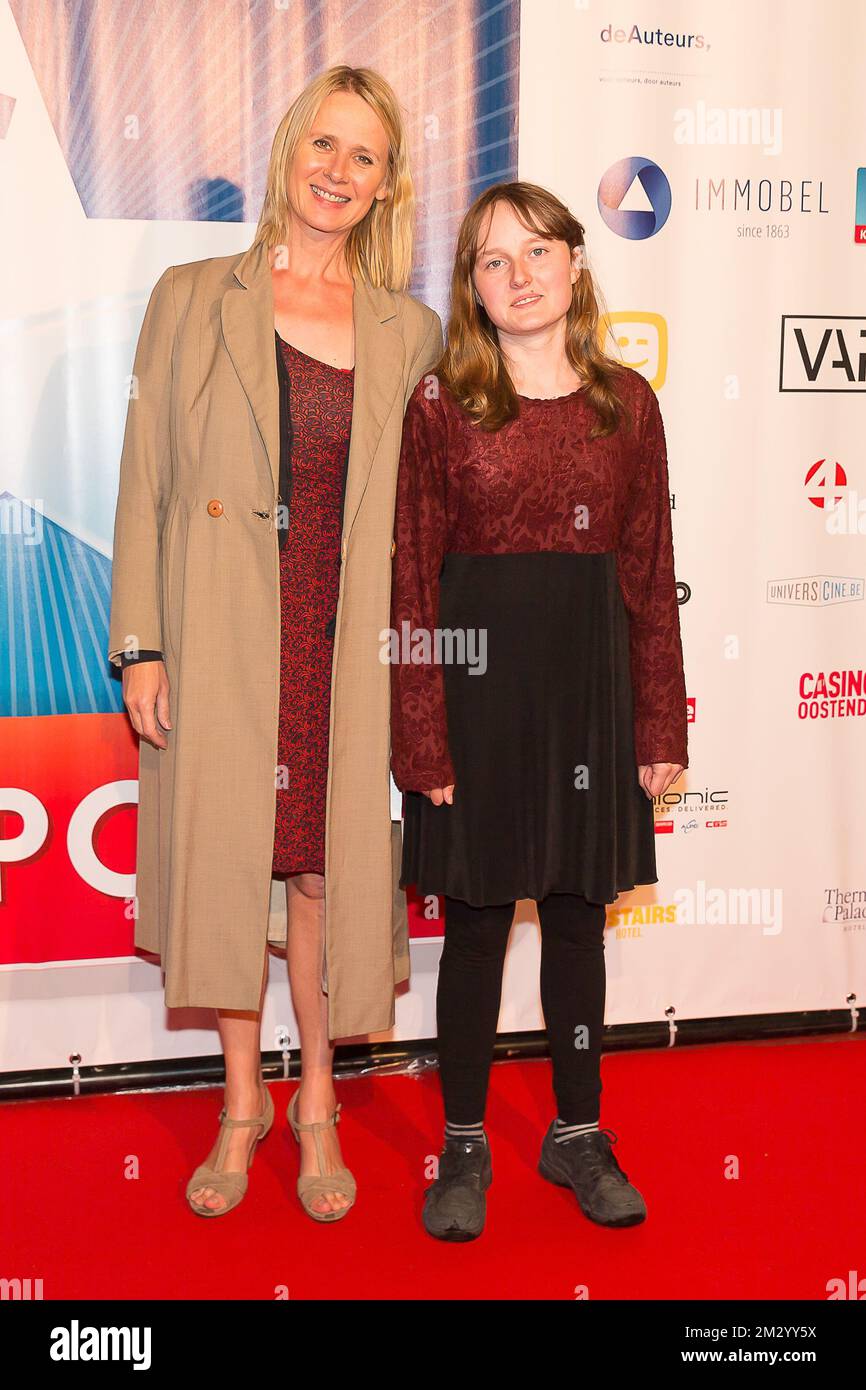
473,202,581,335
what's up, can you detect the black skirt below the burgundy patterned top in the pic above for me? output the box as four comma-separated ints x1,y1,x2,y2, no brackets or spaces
400,550,659,906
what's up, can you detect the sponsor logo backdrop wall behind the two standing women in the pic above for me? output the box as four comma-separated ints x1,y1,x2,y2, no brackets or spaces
0,0,866,1070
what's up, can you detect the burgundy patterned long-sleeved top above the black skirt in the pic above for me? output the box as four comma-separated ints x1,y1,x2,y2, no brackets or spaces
391,370,688,791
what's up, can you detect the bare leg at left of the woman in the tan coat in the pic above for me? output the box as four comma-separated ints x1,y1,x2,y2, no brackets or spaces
190,947,267,1211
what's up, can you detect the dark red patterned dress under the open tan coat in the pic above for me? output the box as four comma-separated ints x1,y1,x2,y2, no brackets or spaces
272,335,354,874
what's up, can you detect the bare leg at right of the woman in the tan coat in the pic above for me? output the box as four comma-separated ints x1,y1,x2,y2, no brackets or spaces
286,873,349,1212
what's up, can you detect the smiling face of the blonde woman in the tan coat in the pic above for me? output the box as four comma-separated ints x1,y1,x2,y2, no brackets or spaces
288,92,388,232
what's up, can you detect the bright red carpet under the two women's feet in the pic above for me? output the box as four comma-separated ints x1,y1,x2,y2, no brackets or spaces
0,1036,866,1300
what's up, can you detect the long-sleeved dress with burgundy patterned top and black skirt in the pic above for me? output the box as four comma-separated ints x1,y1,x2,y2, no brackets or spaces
391,368,688,906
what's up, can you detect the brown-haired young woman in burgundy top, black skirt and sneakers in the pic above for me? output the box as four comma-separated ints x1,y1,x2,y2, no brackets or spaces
392,182,687,1240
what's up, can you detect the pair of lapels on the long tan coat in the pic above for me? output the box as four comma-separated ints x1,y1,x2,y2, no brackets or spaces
220,245,405,539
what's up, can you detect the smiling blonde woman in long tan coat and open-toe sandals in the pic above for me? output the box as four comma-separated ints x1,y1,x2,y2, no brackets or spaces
108,65,442,1220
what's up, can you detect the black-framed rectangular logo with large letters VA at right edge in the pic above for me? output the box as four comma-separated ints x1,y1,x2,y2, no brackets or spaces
778,314,866,392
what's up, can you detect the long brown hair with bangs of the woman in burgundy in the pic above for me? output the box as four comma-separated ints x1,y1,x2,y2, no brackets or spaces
434,181,630,438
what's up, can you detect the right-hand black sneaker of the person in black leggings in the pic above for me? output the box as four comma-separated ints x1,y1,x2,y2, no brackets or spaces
538,1125,646,1226
